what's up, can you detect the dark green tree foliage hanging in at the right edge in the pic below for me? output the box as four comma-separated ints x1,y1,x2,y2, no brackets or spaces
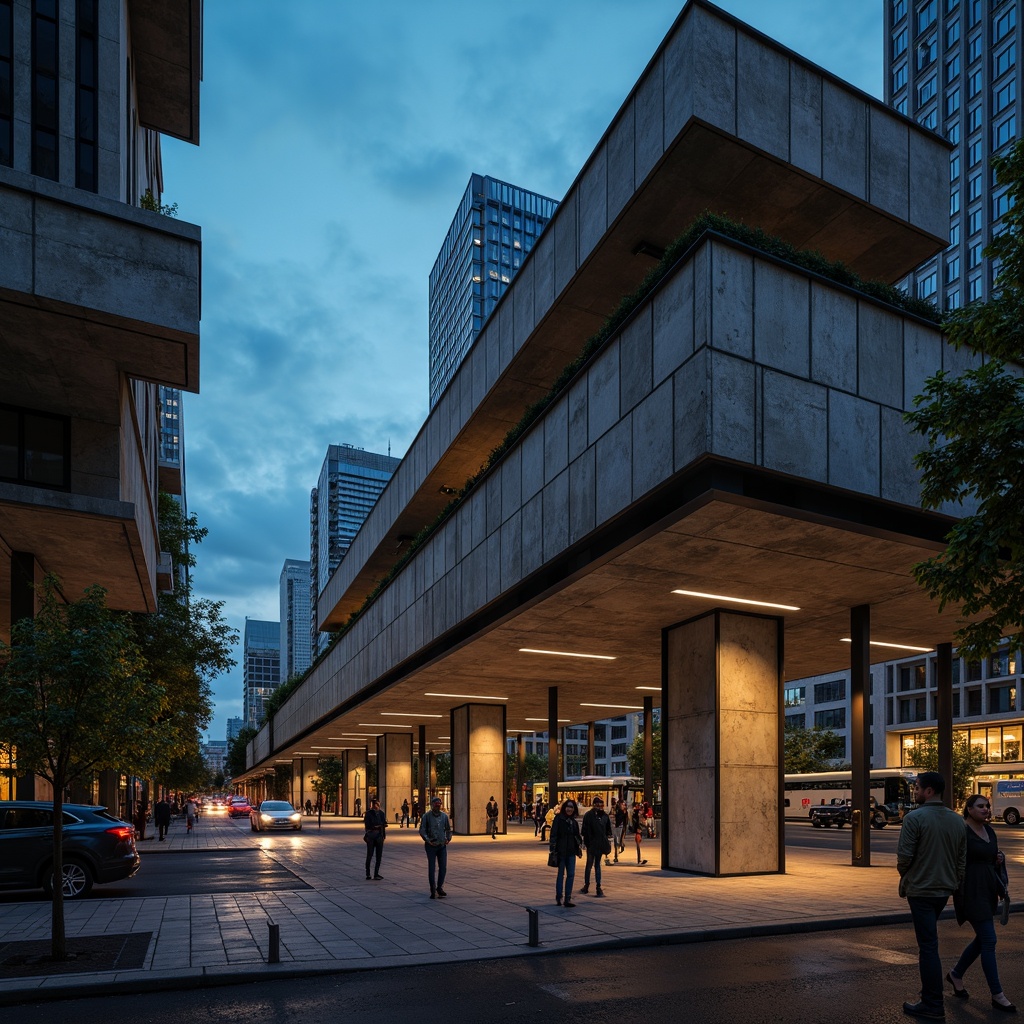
905,140,1024,658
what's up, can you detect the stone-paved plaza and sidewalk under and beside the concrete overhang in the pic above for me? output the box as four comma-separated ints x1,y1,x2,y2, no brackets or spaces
0,815,950,1005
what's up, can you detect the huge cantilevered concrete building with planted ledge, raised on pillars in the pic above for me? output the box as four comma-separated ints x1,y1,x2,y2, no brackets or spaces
230,0,967,876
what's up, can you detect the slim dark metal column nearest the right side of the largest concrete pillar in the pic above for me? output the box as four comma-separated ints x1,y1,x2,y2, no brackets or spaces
850,604,871,867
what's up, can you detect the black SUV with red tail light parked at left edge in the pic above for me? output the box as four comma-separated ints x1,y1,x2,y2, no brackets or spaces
0,800,139,899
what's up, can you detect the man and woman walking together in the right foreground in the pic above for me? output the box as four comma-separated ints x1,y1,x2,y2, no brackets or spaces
896,771,1017,1020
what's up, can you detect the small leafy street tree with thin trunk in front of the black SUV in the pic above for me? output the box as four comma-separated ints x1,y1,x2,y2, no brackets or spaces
0,575,157,961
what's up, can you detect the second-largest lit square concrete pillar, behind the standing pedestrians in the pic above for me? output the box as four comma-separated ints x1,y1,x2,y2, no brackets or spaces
452,703,506,836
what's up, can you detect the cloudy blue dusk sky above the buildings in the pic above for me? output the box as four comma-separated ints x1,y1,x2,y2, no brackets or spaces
163,0,883,738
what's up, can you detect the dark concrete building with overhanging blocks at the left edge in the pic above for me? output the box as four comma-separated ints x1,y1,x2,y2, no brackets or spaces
0,0,203,807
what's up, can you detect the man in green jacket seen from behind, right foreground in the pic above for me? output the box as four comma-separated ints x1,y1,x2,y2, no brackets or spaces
896,771,967,1020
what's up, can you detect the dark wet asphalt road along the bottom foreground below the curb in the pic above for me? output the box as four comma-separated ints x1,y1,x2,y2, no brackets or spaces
14,921,1024,1024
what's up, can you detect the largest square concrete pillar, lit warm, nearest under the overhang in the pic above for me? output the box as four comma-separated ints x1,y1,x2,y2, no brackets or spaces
662,608,785,876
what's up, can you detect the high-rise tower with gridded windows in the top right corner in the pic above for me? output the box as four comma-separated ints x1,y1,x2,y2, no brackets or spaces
884,0,1024,309
